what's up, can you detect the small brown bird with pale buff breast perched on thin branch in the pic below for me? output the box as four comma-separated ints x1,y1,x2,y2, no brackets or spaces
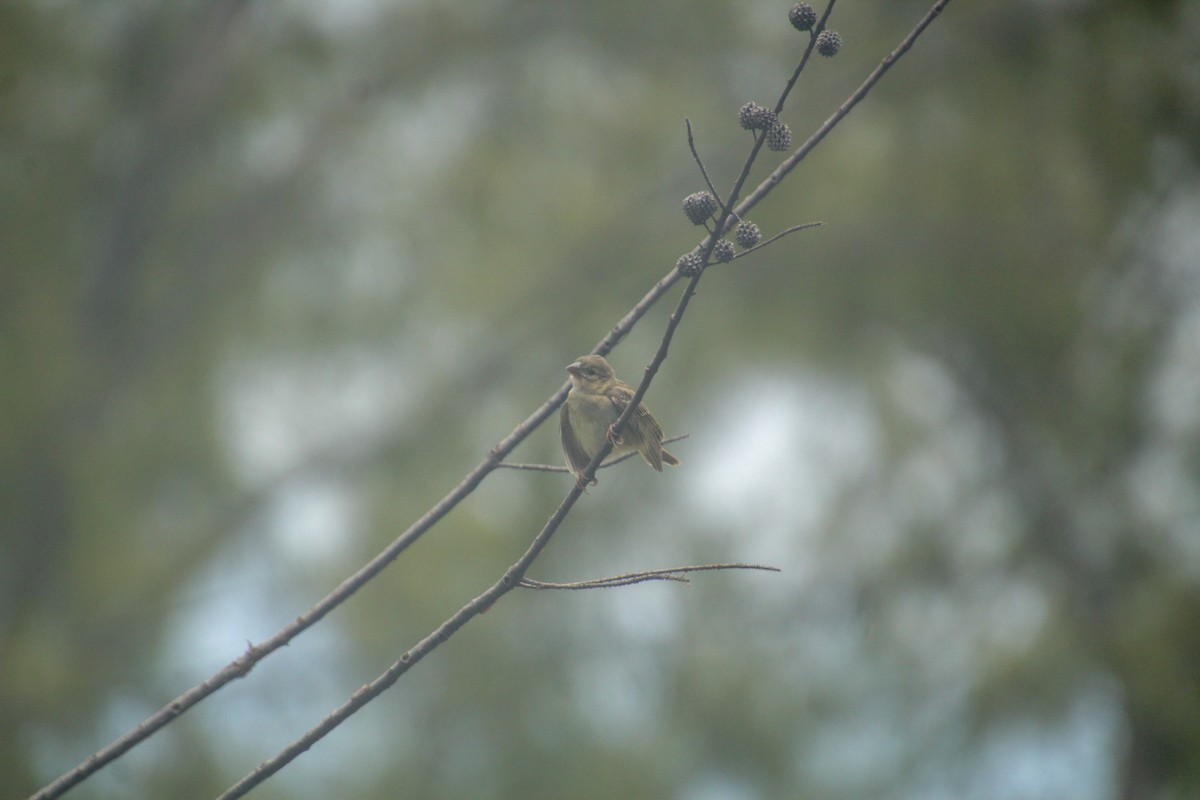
559,355,679,487
